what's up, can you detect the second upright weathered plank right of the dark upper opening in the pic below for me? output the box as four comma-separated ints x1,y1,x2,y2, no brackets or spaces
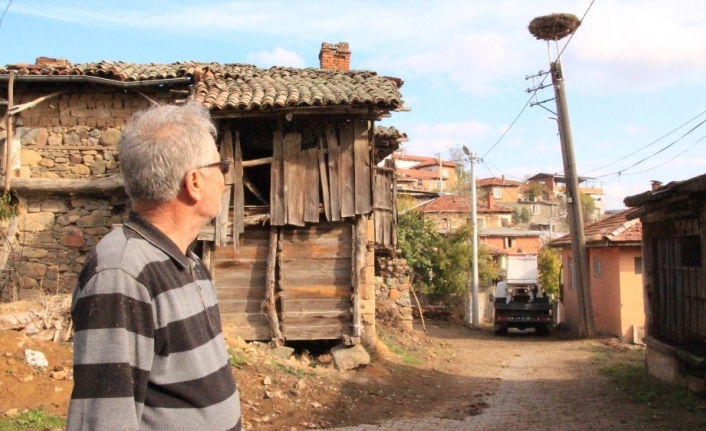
284,133,306,226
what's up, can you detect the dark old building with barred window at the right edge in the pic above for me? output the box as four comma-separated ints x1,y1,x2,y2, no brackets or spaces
624,175,706,392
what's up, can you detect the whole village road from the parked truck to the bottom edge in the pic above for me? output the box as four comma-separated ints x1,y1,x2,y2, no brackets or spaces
324,326,706,431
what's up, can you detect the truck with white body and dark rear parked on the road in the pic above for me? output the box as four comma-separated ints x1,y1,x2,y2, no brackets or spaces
490,254,553,335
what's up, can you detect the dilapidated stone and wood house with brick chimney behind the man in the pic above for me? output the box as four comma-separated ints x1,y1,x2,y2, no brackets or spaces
0,42,405,343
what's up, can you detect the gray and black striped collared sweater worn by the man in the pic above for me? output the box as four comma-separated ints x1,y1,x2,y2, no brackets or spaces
67,213,241,431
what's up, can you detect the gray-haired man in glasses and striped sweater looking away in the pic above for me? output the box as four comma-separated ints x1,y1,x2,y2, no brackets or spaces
67,103,241,431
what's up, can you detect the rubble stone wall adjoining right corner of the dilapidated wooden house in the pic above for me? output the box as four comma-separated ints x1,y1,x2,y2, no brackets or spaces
375,256,413,329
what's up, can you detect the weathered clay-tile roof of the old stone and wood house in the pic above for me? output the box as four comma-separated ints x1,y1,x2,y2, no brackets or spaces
0,61,403,110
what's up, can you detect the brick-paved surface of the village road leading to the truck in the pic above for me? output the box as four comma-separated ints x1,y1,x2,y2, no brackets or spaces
324,328,706,431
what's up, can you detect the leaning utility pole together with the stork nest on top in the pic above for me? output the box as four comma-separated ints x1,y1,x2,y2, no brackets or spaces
528,14,595,337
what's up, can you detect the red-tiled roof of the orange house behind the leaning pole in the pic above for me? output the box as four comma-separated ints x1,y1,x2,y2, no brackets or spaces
550,209,642,246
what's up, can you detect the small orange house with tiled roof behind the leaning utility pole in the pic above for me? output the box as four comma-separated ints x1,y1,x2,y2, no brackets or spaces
549,210,645,342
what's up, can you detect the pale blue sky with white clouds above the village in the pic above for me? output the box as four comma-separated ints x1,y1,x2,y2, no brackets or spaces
0,0,706,209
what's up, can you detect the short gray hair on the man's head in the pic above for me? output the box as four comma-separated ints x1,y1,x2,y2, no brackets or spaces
120,102,216,203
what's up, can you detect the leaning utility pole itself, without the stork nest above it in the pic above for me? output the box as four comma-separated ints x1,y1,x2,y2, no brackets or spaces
550,60,596,337
